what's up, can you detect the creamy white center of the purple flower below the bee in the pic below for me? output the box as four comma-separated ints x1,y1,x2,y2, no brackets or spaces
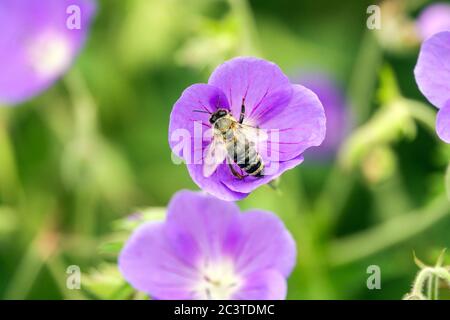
194,260,242,300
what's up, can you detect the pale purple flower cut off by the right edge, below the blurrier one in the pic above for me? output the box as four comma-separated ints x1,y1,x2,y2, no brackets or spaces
414,31,450,143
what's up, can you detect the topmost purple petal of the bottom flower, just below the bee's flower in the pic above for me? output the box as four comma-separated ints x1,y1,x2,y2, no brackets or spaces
167,191,243,260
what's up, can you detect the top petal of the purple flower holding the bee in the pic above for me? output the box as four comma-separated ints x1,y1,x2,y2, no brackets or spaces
208,57,292,125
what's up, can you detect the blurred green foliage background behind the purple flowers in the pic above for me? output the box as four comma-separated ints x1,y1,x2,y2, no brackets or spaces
0,0,450,299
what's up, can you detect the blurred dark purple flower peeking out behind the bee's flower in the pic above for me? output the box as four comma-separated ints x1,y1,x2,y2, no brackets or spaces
298,73,351,159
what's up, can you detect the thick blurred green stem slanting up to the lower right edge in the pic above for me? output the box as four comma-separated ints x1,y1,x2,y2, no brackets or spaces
329,195,449,266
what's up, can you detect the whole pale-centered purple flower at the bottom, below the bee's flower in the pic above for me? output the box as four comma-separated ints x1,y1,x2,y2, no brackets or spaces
119,191,296,300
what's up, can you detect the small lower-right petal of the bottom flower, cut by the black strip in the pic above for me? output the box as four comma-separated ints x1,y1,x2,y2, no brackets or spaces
232,270,287,300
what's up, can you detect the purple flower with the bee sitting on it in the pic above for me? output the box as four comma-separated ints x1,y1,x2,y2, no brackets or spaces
169,58,325,201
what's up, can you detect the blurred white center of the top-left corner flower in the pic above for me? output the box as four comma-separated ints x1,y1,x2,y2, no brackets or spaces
28,32,71,78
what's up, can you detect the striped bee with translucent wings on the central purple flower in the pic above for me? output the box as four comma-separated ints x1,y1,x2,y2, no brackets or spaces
195,98,267,179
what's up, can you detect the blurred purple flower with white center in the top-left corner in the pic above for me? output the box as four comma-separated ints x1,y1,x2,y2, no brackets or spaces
0,0,95,104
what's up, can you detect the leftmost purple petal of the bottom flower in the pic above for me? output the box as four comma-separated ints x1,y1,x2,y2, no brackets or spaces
119,223,197,299
